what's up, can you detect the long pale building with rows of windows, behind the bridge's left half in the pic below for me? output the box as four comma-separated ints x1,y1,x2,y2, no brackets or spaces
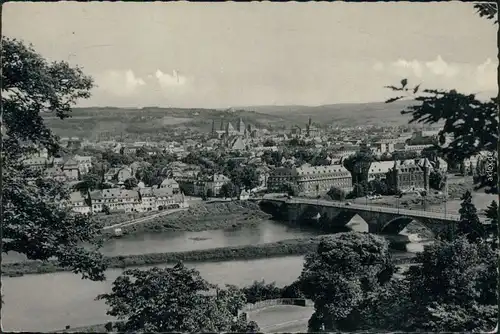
267,165,352,195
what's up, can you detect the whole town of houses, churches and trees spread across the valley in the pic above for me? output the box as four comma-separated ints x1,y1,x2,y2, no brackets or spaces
24,120,480,214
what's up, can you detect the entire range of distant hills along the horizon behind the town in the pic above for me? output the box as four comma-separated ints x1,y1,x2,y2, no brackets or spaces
44,102,418,140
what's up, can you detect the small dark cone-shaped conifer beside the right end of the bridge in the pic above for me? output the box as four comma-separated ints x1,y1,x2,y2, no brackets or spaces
457,190,486,242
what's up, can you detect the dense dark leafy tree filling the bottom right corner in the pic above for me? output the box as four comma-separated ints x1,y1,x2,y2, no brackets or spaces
400,237,498,332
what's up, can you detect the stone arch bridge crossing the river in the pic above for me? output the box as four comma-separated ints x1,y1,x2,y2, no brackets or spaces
259,198,484,235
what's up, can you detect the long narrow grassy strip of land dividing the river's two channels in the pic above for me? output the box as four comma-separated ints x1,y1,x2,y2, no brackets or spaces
2,236,414,276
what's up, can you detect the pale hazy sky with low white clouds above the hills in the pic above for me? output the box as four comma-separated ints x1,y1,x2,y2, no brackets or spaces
2,2,498,108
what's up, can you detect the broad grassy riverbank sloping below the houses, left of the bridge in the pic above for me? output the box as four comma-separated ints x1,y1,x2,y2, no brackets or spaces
112,201,270,234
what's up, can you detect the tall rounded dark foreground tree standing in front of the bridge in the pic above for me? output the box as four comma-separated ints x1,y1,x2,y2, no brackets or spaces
299,232,394,331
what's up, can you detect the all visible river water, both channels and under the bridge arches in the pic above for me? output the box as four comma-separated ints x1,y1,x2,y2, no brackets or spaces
2,206,470,331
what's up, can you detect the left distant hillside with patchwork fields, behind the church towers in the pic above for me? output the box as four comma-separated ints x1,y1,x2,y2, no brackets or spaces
44,107,293,140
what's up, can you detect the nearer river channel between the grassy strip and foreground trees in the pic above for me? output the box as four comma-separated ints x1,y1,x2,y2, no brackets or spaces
2,256,303,332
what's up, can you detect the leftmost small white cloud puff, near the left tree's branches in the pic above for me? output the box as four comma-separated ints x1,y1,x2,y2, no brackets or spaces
96,70,146,96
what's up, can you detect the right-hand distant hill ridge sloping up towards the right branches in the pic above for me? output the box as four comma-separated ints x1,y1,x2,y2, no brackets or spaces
241,101,414,126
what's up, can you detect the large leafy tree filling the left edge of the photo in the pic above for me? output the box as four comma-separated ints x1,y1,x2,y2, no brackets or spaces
0,38,106,280
